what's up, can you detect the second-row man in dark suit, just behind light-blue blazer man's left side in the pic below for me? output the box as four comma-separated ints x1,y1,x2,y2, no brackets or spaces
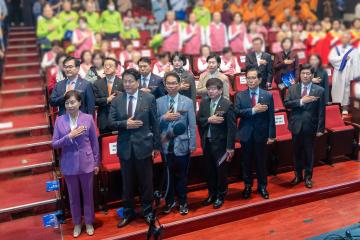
138,57,165,99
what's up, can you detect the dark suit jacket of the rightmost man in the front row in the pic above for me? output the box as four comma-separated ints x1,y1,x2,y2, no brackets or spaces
285,83,325,134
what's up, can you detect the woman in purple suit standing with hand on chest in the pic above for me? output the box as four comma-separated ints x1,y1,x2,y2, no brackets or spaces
52,90,99,237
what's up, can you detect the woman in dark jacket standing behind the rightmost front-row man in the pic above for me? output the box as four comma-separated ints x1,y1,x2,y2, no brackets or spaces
309,54,330,104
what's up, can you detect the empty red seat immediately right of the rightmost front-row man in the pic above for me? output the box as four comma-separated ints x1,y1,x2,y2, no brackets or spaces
325,104,359,162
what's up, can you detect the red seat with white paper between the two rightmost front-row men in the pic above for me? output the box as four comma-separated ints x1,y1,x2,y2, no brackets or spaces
271,111,293,173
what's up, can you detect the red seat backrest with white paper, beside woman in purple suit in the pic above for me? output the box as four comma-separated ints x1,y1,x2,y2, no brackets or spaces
101,135,119,165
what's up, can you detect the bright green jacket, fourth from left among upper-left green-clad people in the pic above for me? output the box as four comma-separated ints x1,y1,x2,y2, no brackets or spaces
100,10,123,33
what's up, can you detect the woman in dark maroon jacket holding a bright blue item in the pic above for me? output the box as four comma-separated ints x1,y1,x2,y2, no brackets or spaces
274,38,299,99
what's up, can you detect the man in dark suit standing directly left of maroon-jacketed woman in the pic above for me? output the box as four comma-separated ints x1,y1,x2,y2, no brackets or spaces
245,37,273,90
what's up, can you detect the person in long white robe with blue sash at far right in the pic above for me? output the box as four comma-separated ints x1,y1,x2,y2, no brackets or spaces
329,32,360,115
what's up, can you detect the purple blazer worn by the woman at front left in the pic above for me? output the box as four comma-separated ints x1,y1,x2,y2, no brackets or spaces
52,111,99,175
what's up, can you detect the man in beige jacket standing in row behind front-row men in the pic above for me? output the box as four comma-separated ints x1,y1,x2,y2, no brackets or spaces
196,53,230,100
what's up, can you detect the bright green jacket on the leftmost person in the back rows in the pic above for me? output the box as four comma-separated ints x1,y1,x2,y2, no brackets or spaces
36,16,63,42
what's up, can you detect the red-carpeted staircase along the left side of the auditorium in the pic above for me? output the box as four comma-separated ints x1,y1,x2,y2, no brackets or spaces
0,27,58,239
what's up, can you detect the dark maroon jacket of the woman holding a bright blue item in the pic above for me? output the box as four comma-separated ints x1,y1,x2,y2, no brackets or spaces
274,52,300,84
